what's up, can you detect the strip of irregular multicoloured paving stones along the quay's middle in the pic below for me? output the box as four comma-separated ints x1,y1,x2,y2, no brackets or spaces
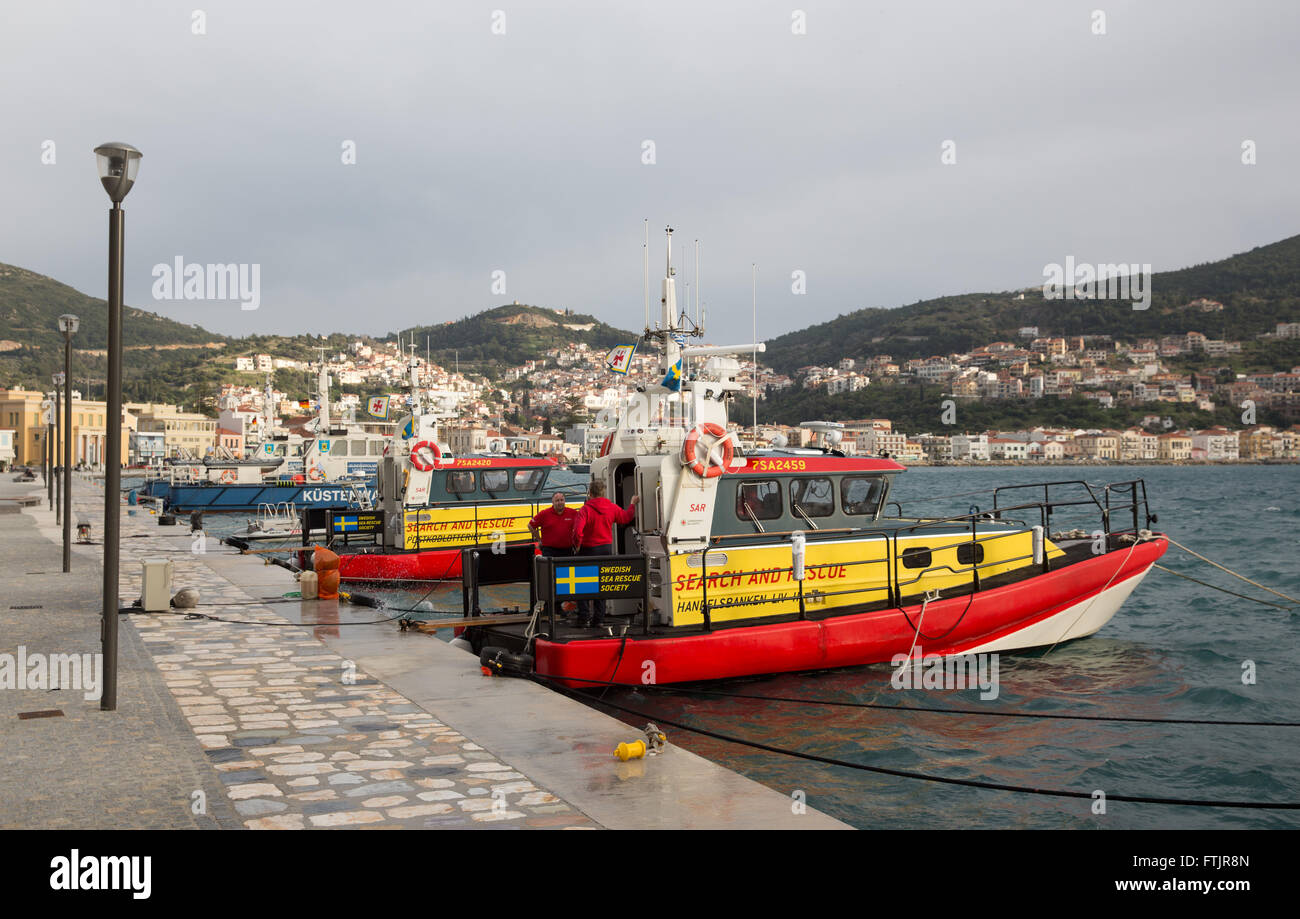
110,486,597,829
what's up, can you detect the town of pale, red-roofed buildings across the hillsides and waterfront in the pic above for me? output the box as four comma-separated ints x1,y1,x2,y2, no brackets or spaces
0,314,1300,468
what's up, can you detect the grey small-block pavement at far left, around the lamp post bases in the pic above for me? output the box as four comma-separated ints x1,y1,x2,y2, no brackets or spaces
0,476,242,829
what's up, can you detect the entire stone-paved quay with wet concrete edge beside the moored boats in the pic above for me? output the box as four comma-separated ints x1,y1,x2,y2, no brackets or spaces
0,476,846,829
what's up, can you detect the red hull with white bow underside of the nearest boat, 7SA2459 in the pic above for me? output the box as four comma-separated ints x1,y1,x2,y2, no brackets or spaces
534,537,1167,688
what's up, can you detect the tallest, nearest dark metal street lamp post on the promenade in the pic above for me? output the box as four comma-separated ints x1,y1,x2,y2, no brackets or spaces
95,143,142,711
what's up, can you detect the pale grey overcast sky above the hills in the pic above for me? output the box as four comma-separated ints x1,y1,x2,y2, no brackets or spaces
0,0,1300,342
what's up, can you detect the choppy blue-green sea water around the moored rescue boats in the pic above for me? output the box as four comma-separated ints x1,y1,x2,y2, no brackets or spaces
157,465,1300,829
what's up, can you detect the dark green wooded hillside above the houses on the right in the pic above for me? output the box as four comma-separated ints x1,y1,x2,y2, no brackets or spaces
766,237,1300,373
